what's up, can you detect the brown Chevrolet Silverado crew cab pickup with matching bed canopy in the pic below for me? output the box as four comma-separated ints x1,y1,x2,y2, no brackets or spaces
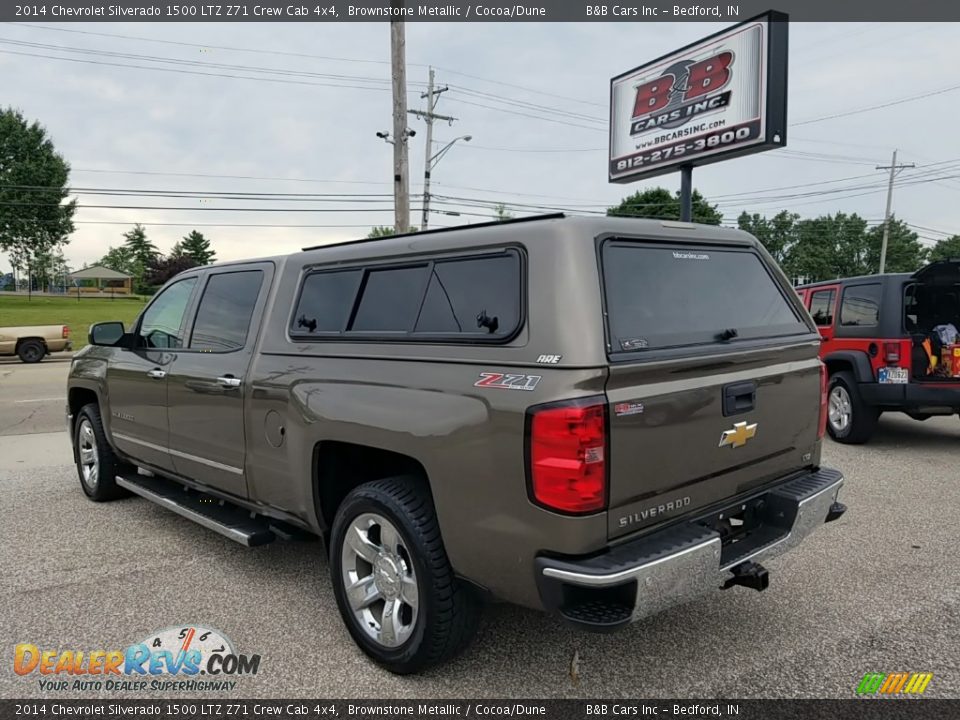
66,216,846,673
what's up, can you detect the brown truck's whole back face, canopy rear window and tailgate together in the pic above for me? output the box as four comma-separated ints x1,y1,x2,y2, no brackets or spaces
601,238,821,537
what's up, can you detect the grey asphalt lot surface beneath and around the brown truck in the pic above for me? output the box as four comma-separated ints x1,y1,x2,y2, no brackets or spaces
0,359,960,698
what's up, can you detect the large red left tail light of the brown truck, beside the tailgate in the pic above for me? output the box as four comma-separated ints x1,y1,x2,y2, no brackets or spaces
527,401,607,514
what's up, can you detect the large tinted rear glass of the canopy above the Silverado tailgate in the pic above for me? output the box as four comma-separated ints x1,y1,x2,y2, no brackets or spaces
602,241,809,352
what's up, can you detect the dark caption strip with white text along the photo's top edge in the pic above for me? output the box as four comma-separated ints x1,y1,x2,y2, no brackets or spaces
0,0,960,22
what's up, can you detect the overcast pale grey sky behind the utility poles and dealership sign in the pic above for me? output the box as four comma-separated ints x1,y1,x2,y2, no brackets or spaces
0,22,960,271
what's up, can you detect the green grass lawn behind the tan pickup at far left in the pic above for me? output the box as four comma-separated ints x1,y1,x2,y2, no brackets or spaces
0,295,144,350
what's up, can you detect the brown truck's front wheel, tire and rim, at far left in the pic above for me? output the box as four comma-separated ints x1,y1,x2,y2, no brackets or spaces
73,403,134,502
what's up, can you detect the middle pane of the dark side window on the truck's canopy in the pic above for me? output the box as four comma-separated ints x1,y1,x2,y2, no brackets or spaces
350,265,427,332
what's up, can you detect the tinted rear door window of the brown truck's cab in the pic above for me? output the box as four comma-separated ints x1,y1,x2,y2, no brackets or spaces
190,270,263,351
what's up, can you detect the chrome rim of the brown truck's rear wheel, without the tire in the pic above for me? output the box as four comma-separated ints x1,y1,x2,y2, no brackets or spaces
340,513,420,648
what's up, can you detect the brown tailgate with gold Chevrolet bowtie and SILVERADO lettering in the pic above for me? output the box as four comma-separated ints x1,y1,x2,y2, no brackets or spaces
607,343,820,537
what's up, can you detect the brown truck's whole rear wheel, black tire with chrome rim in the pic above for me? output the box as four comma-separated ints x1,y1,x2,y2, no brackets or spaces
330,477,480,675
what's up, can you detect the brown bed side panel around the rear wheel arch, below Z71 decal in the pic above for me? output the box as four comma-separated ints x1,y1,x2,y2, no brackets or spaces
247,356,606,606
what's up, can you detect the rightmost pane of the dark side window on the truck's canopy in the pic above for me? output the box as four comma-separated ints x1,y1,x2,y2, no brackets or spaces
416,254,520,336
